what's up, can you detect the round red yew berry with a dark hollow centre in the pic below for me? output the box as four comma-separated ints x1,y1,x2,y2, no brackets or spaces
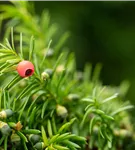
17,60,34,77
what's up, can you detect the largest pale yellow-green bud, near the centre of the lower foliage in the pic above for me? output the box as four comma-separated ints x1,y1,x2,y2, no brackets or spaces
56,105,68,118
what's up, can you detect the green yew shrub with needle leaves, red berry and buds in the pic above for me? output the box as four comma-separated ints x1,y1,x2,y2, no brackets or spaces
0,0,134,150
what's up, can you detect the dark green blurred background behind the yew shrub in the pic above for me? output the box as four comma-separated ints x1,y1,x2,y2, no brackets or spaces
1,0,135,104
